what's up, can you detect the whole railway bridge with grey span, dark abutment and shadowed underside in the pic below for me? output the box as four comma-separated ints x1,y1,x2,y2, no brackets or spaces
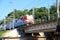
0,19,60,40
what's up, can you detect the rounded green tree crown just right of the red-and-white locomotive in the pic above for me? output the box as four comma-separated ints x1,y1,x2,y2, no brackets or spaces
29,7,48,19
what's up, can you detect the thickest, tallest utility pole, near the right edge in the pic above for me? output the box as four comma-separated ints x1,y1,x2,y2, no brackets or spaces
55,0,60,40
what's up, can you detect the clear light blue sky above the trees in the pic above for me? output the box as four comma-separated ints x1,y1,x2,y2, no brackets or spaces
0,0,60,20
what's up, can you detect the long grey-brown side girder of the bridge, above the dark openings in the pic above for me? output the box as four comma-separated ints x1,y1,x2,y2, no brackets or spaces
25,21,57,33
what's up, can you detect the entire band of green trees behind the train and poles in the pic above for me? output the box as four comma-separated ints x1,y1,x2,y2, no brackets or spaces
0,5,60,24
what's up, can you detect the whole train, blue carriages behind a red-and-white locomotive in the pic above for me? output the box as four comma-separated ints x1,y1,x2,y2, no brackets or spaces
6,14,34,29
